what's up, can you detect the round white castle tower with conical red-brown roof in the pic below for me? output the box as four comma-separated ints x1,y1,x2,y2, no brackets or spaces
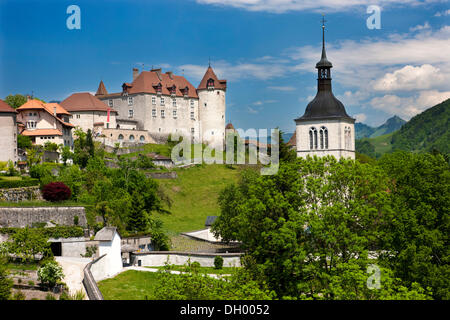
197,65,227,147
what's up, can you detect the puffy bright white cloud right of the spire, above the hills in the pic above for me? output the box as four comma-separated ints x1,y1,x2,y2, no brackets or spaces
374,64,446,91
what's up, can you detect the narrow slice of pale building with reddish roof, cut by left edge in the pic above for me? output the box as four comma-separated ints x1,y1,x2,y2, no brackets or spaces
0,99,18,164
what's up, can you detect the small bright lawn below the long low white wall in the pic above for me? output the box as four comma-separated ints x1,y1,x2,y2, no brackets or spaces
98,270,158,300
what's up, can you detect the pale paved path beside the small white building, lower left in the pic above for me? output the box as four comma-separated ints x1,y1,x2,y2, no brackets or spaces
55,257,92,299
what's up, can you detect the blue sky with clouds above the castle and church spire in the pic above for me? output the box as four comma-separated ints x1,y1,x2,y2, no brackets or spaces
0,0,450,132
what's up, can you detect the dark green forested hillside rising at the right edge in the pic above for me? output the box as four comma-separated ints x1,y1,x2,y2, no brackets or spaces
392,99,450,154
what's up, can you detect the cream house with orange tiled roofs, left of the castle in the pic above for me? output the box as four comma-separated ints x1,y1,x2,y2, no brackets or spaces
16,99,74,147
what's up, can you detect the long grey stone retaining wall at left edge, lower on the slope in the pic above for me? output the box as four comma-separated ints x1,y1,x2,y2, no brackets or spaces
0,207,87,228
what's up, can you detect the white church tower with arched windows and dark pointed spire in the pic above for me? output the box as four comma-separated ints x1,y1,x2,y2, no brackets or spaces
295,20,355,159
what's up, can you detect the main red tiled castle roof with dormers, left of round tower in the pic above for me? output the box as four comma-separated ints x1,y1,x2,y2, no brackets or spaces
124,70,198,98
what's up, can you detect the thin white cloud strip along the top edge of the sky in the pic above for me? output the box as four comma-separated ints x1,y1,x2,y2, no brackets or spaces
197,0,430,13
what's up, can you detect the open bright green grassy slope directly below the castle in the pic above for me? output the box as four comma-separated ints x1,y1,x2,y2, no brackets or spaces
156,165,240,233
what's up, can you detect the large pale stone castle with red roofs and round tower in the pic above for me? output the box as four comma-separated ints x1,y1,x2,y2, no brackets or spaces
96,66,226,149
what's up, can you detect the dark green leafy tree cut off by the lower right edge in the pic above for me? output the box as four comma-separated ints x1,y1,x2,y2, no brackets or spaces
380,152,450,299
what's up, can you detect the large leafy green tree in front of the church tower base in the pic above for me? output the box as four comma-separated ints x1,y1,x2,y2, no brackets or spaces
212,157,426,299
